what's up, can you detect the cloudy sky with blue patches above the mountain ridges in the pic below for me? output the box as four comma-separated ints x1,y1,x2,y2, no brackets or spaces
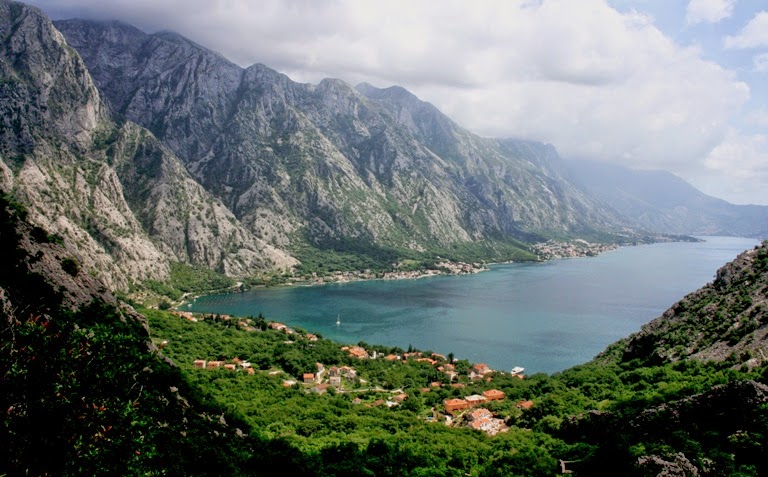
27,0,768,205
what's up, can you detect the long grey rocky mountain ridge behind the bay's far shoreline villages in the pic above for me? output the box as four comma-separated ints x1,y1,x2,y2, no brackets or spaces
55,20,628,264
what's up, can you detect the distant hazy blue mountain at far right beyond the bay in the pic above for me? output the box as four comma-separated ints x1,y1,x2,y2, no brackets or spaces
566,160,768,237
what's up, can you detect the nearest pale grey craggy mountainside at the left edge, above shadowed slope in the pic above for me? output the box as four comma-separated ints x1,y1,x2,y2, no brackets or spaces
0,1,295,289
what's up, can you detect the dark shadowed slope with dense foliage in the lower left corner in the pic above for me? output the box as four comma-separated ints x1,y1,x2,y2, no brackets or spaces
0,195,269,475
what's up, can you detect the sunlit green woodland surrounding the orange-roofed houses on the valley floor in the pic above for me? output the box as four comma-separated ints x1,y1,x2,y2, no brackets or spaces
140,310,768,475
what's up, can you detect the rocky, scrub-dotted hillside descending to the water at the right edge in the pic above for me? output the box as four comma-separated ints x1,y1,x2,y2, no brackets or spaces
603,242,768,367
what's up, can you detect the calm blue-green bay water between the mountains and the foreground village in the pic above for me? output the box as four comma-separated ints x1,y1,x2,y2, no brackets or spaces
189,237,758,373
